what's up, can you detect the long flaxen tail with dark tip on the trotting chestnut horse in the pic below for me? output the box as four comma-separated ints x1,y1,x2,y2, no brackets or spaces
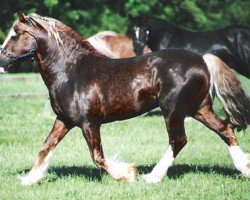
203,54,250,130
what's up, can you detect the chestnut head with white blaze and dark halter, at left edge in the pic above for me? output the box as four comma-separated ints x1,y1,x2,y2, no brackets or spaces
0,12,36,73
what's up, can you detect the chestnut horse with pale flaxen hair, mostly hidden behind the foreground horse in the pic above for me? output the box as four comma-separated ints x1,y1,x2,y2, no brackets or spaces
87,31,151,58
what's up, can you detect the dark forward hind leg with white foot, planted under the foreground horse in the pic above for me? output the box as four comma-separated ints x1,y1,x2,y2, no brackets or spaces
143,73,207,183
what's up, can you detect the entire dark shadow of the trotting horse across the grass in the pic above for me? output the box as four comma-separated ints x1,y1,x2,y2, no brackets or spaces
20,164,244,182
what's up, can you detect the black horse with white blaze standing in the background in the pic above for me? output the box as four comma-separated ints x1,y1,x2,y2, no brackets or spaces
128,15,250,78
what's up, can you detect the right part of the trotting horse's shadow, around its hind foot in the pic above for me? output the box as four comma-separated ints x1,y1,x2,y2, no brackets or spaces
137,164,241,179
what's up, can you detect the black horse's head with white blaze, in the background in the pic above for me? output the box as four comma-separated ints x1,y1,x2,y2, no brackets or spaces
127,16,150,55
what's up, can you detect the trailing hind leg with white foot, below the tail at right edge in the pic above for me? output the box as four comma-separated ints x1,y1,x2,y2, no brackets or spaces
194,96,250,177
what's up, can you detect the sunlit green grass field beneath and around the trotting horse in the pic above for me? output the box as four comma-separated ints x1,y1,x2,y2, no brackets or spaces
0,75,250,200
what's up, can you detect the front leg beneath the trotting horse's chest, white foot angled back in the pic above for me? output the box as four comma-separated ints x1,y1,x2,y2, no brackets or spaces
82,122,136,182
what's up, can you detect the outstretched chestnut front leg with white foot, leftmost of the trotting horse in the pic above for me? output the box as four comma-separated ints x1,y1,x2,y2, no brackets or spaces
20,118,71,185
